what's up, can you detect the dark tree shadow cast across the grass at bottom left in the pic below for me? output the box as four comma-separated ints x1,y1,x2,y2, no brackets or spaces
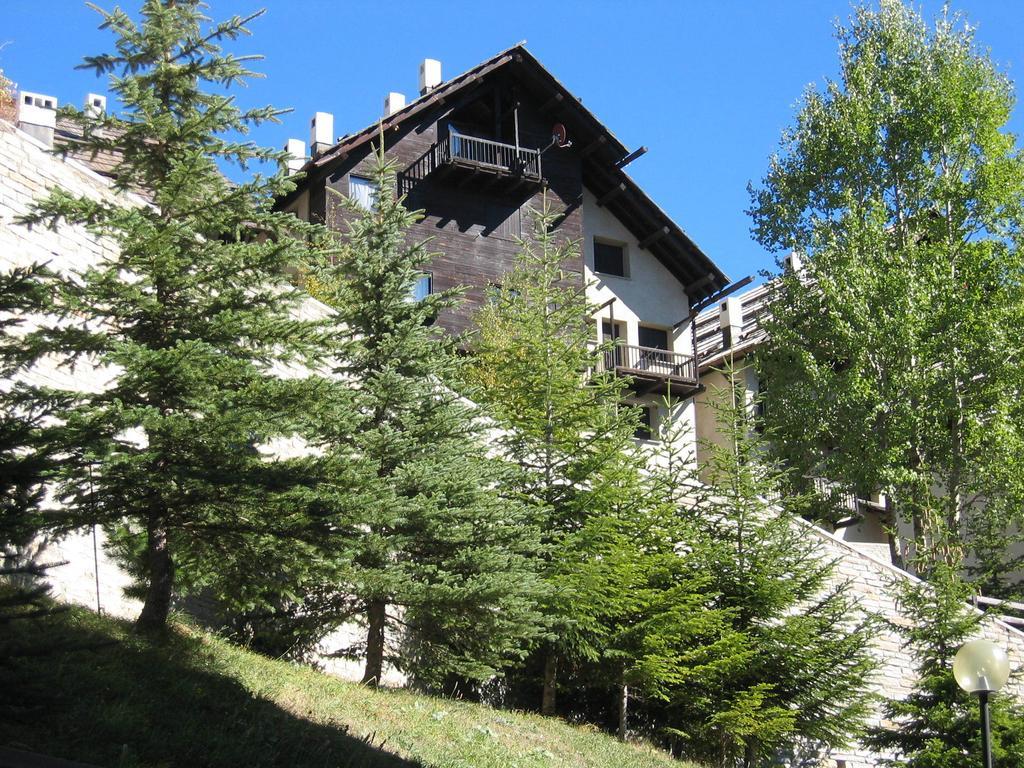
0,610,422,768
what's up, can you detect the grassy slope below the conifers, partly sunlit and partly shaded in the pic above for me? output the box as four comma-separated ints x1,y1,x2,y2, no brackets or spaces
0,609,696,768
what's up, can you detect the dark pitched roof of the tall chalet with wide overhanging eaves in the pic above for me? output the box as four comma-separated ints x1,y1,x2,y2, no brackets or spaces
283,44,729,303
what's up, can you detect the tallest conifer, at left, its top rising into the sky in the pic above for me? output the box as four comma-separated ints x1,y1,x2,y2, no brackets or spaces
27,0,335,632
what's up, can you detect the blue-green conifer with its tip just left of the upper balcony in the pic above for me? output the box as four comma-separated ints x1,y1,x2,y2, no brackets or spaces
312,144,541,687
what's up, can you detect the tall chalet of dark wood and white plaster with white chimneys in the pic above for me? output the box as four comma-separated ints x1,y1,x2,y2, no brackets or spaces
280,45,729,438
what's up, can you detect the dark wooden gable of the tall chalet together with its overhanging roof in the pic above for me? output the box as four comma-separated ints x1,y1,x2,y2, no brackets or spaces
281,46,727,334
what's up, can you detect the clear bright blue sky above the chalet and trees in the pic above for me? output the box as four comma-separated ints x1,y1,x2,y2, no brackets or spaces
0,0,1024,279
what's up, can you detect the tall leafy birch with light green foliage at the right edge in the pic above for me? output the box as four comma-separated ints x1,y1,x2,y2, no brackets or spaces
750,0,1024,591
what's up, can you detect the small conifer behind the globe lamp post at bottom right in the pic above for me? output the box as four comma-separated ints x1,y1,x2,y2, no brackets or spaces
868,561,1024,768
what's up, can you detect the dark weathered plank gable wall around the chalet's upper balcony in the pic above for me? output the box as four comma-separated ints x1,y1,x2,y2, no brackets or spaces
310,72,583,334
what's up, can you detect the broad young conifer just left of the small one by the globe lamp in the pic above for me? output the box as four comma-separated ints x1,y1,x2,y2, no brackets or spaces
667,370,872,768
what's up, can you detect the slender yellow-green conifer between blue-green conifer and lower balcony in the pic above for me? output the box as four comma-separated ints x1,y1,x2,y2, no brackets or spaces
468,201,664,730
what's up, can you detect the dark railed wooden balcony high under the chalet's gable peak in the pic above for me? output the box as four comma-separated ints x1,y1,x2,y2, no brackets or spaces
401,133,544,191
